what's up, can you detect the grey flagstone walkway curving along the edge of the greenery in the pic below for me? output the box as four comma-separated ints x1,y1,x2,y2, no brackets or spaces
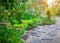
22,17,60,43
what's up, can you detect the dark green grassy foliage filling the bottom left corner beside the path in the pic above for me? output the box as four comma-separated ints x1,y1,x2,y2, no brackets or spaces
0,29,23,43
